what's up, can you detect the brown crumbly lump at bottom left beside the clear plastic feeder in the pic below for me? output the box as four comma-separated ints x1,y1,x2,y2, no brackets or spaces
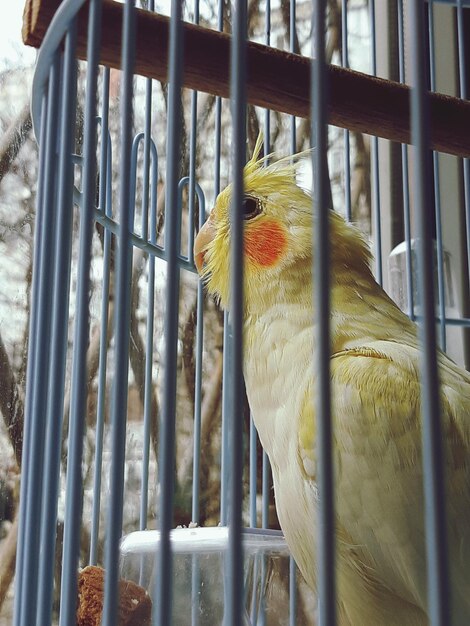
77,565,152,626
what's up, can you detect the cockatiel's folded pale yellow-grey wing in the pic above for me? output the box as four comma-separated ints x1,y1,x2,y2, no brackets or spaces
299,341,470,607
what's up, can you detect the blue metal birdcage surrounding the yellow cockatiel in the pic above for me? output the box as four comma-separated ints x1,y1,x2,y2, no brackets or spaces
6,0,470,626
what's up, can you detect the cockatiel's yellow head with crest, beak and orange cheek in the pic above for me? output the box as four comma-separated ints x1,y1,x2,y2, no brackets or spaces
194,136,369,310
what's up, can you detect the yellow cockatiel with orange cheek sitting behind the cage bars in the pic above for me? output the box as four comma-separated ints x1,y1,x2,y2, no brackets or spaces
194,136,470,626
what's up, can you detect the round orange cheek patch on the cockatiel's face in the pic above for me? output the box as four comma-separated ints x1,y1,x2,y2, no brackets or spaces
245,219,287,267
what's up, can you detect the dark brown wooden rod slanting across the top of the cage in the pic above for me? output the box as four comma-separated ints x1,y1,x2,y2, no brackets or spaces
23,0,470,157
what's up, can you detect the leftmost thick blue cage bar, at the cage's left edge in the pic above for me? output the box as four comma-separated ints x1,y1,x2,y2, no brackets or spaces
20,53,60,626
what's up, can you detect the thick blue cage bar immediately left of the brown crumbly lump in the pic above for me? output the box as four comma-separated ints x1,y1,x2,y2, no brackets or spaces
59,0,101,626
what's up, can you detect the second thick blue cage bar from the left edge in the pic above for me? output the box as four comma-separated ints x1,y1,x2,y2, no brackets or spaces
37,20,77,626
